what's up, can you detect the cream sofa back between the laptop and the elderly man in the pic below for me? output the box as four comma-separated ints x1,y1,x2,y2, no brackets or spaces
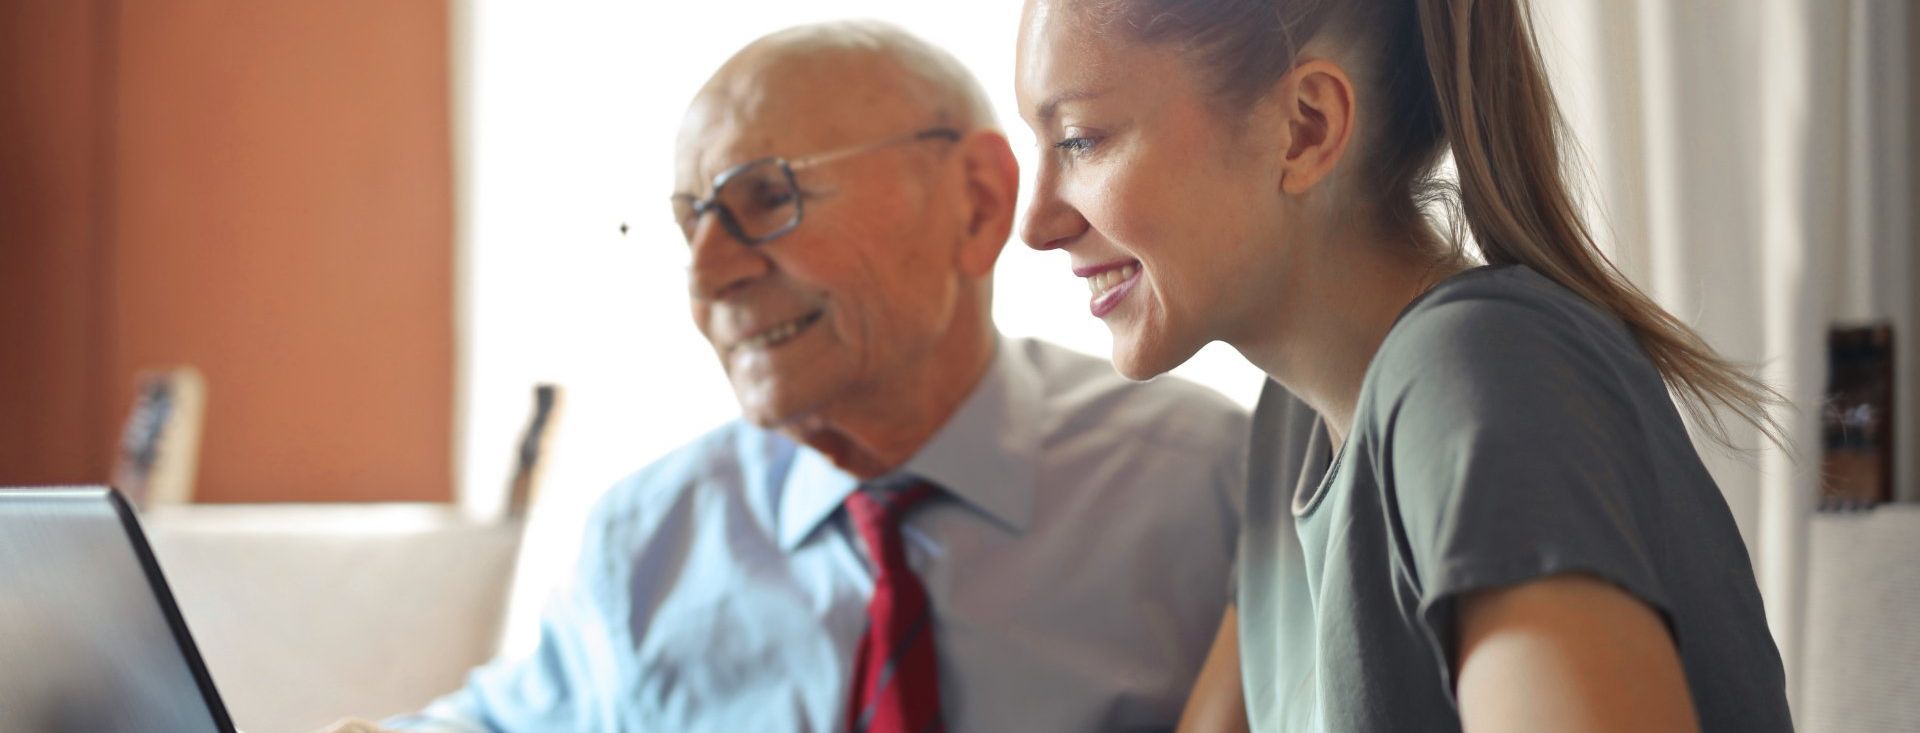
142,505,520,733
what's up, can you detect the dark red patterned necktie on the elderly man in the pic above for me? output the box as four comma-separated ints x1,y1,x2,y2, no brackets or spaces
847,482,947,733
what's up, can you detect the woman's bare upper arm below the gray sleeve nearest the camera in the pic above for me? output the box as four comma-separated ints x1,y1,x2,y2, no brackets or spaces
1443,574,1699,733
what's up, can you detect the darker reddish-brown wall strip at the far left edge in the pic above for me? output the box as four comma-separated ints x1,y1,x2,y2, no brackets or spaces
0,2,108,484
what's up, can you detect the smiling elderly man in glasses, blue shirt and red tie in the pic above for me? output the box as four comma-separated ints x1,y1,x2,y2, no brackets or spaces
326,23,1246,733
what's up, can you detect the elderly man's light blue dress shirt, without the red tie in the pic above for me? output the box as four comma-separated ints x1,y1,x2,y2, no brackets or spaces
397,340,1248,733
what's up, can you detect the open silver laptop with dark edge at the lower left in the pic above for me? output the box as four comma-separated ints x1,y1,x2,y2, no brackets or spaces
0,487,234,733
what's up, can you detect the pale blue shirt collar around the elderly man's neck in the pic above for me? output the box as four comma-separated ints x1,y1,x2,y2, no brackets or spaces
778,340,1043,553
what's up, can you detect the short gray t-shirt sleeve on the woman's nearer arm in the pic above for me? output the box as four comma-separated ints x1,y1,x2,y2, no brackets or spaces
1363,299,1670,674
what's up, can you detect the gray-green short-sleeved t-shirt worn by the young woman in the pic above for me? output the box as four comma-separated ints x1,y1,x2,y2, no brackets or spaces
1236,267,1791,733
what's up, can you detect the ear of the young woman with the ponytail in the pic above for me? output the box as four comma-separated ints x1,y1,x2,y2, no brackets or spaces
1265,58,1356,196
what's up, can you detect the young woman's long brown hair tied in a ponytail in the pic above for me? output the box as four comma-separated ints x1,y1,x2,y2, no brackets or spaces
1094,0,1784,445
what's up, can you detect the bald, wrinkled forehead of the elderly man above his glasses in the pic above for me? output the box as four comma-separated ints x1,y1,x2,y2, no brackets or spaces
674,52,925,196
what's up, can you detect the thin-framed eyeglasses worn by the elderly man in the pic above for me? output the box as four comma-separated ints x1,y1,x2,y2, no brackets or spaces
674,127,960,246
